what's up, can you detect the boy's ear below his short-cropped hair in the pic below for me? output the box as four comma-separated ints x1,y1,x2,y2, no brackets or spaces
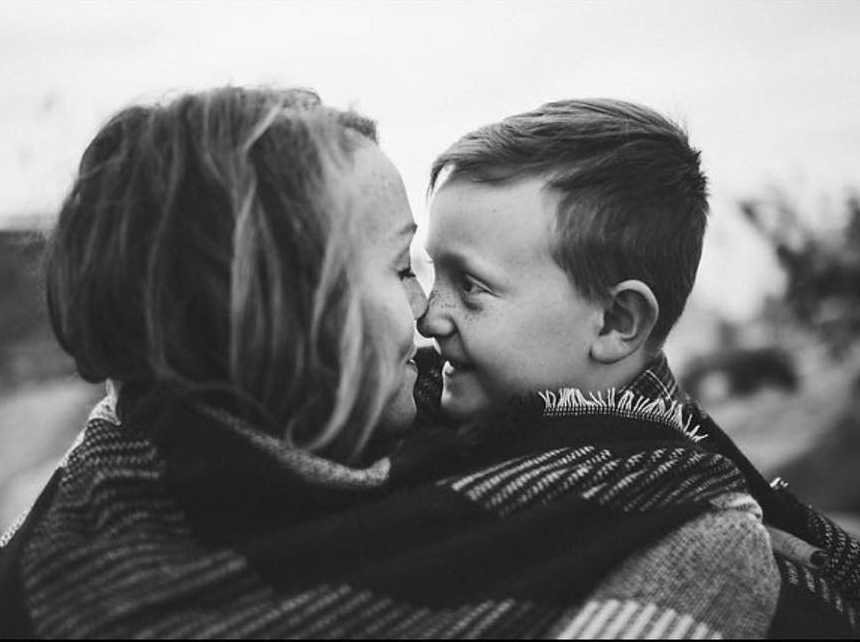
591,279,660,364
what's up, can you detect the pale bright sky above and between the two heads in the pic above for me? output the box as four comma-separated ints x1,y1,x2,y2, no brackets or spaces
0,0,860,317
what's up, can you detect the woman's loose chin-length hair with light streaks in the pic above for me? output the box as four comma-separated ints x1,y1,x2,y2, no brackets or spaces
47,87,395,460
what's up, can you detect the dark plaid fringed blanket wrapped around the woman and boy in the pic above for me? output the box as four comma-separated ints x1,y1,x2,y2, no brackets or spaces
0,350,853,638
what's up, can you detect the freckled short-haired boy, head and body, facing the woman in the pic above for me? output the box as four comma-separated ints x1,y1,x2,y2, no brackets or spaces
419,100,858,637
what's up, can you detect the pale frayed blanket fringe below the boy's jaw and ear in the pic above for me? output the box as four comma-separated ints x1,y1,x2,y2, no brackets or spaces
538,388,707,442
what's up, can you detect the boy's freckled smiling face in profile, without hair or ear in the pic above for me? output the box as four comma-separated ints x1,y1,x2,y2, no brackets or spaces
418,178,603,419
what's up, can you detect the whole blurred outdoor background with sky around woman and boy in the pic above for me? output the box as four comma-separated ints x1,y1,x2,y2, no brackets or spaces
0,0,860,533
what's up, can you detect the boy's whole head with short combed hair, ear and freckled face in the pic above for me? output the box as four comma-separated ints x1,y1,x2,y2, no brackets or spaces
420,101,708,417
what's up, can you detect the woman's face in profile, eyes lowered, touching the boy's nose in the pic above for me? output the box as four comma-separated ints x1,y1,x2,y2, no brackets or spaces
351,144,427,432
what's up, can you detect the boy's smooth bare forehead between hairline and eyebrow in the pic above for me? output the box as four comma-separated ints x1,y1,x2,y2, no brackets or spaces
427,177,559,261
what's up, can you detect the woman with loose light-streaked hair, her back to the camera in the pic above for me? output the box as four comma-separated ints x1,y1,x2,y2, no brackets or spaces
0,88,426,636
